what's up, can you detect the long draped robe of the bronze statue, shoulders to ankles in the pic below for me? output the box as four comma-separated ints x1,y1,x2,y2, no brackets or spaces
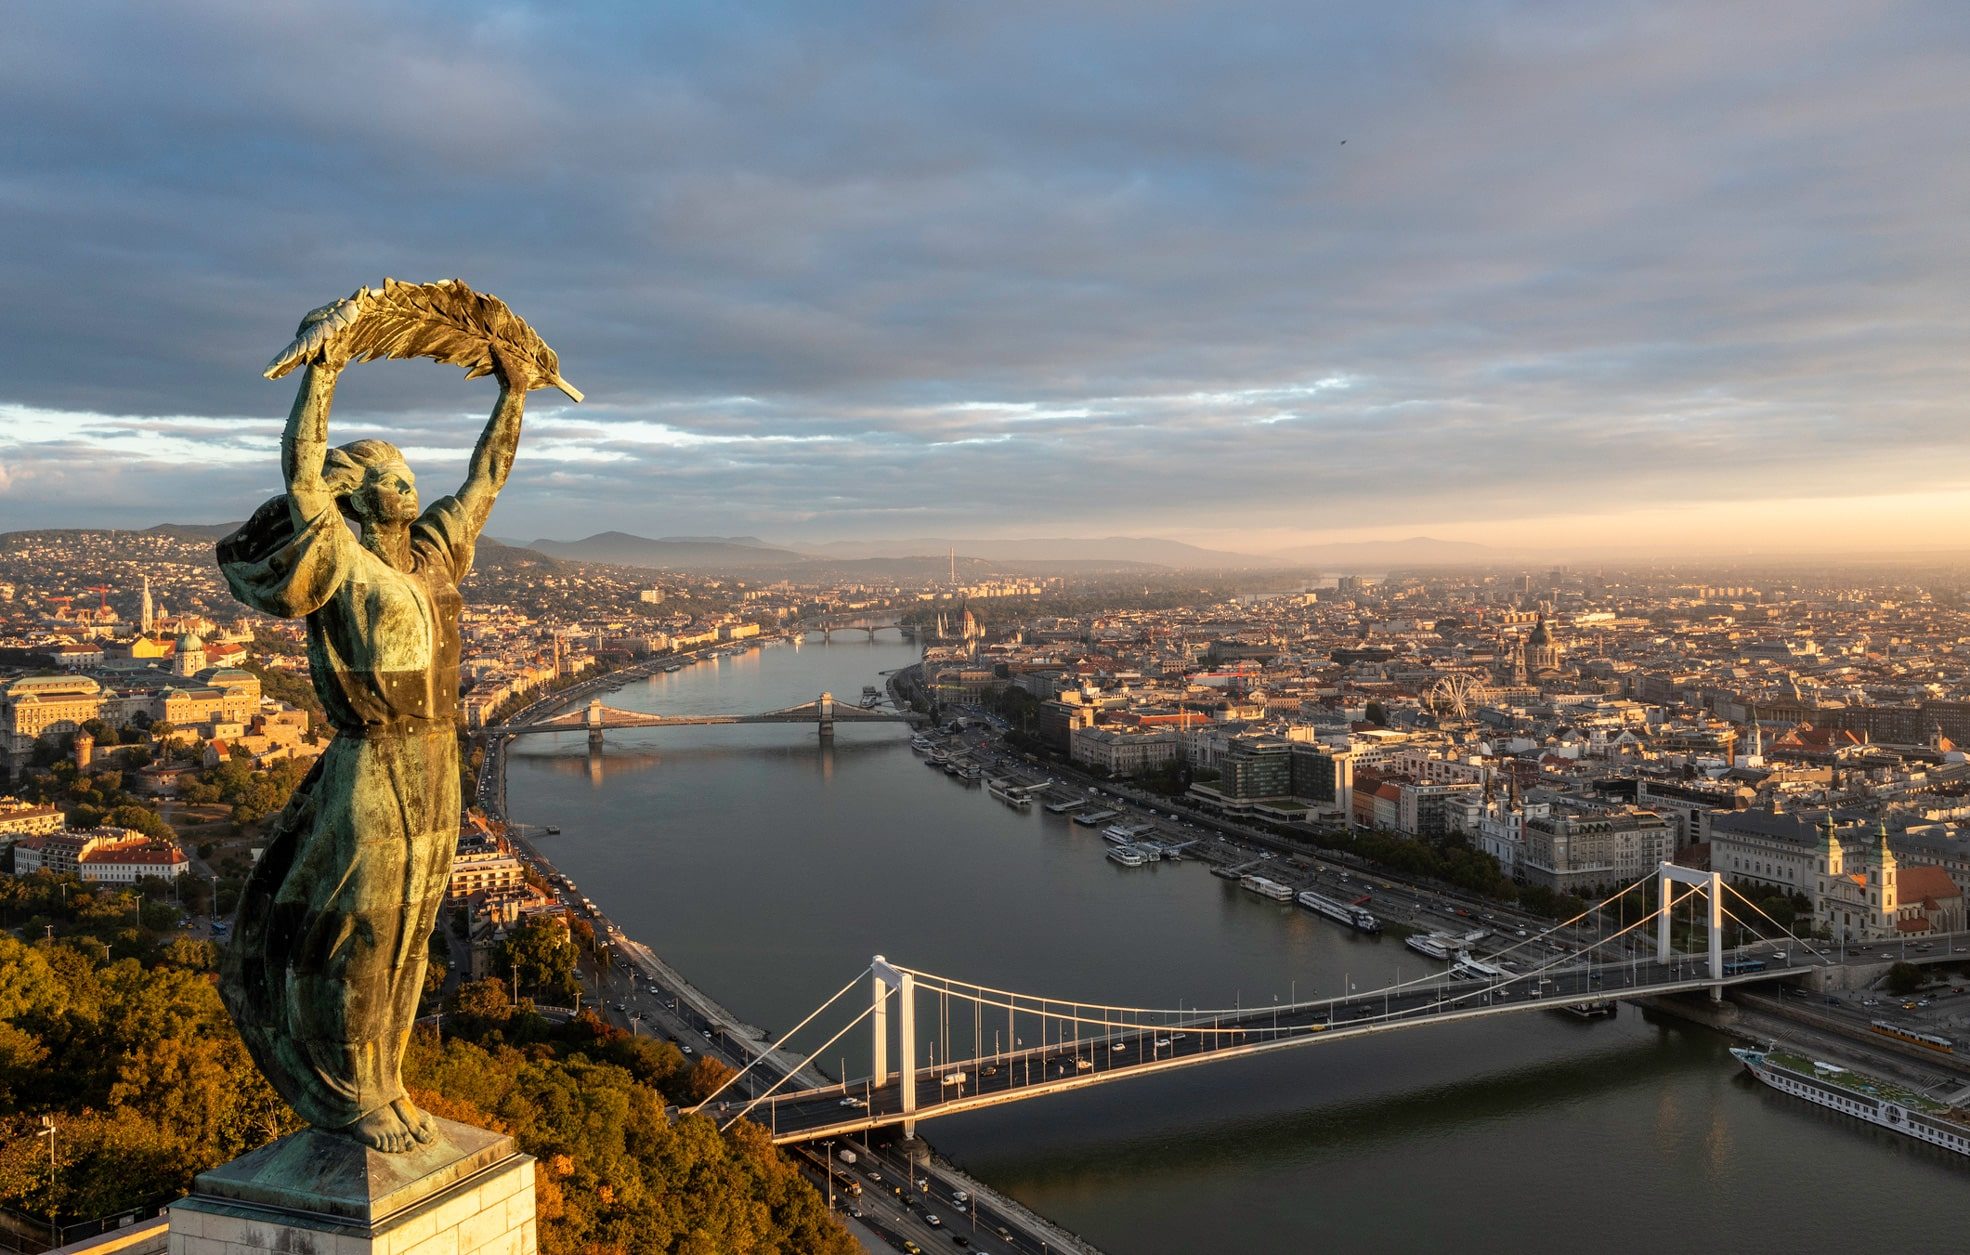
219,496,477,1129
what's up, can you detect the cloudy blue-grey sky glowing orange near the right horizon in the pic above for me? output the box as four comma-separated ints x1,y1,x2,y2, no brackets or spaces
0,0,1970,550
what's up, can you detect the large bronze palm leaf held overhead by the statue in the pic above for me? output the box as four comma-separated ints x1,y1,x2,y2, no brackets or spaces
266,280,581,400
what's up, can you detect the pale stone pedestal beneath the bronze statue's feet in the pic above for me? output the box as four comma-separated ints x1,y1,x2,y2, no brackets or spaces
169,1119,538,1255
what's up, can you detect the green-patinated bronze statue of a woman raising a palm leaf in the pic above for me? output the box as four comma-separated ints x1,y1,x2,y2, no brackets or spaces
219,280,579,1153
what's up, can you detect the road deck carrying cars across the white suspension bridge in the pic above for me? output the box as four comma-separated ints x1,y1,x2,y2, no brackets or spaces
740,958,1820,1143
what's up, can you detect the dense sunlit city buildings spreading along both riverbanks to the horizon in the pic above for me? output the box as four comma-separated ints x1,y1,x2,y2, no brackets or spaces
11,528,1970,1249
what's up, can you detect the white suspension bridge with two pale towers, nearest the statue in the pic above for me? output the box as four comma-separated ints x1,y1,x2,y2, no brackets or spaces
693,863,1832,1143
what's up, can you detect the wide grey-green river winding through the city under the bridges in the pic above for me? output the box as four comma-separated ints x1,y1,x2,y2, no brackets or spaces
508,636,1970,1255
